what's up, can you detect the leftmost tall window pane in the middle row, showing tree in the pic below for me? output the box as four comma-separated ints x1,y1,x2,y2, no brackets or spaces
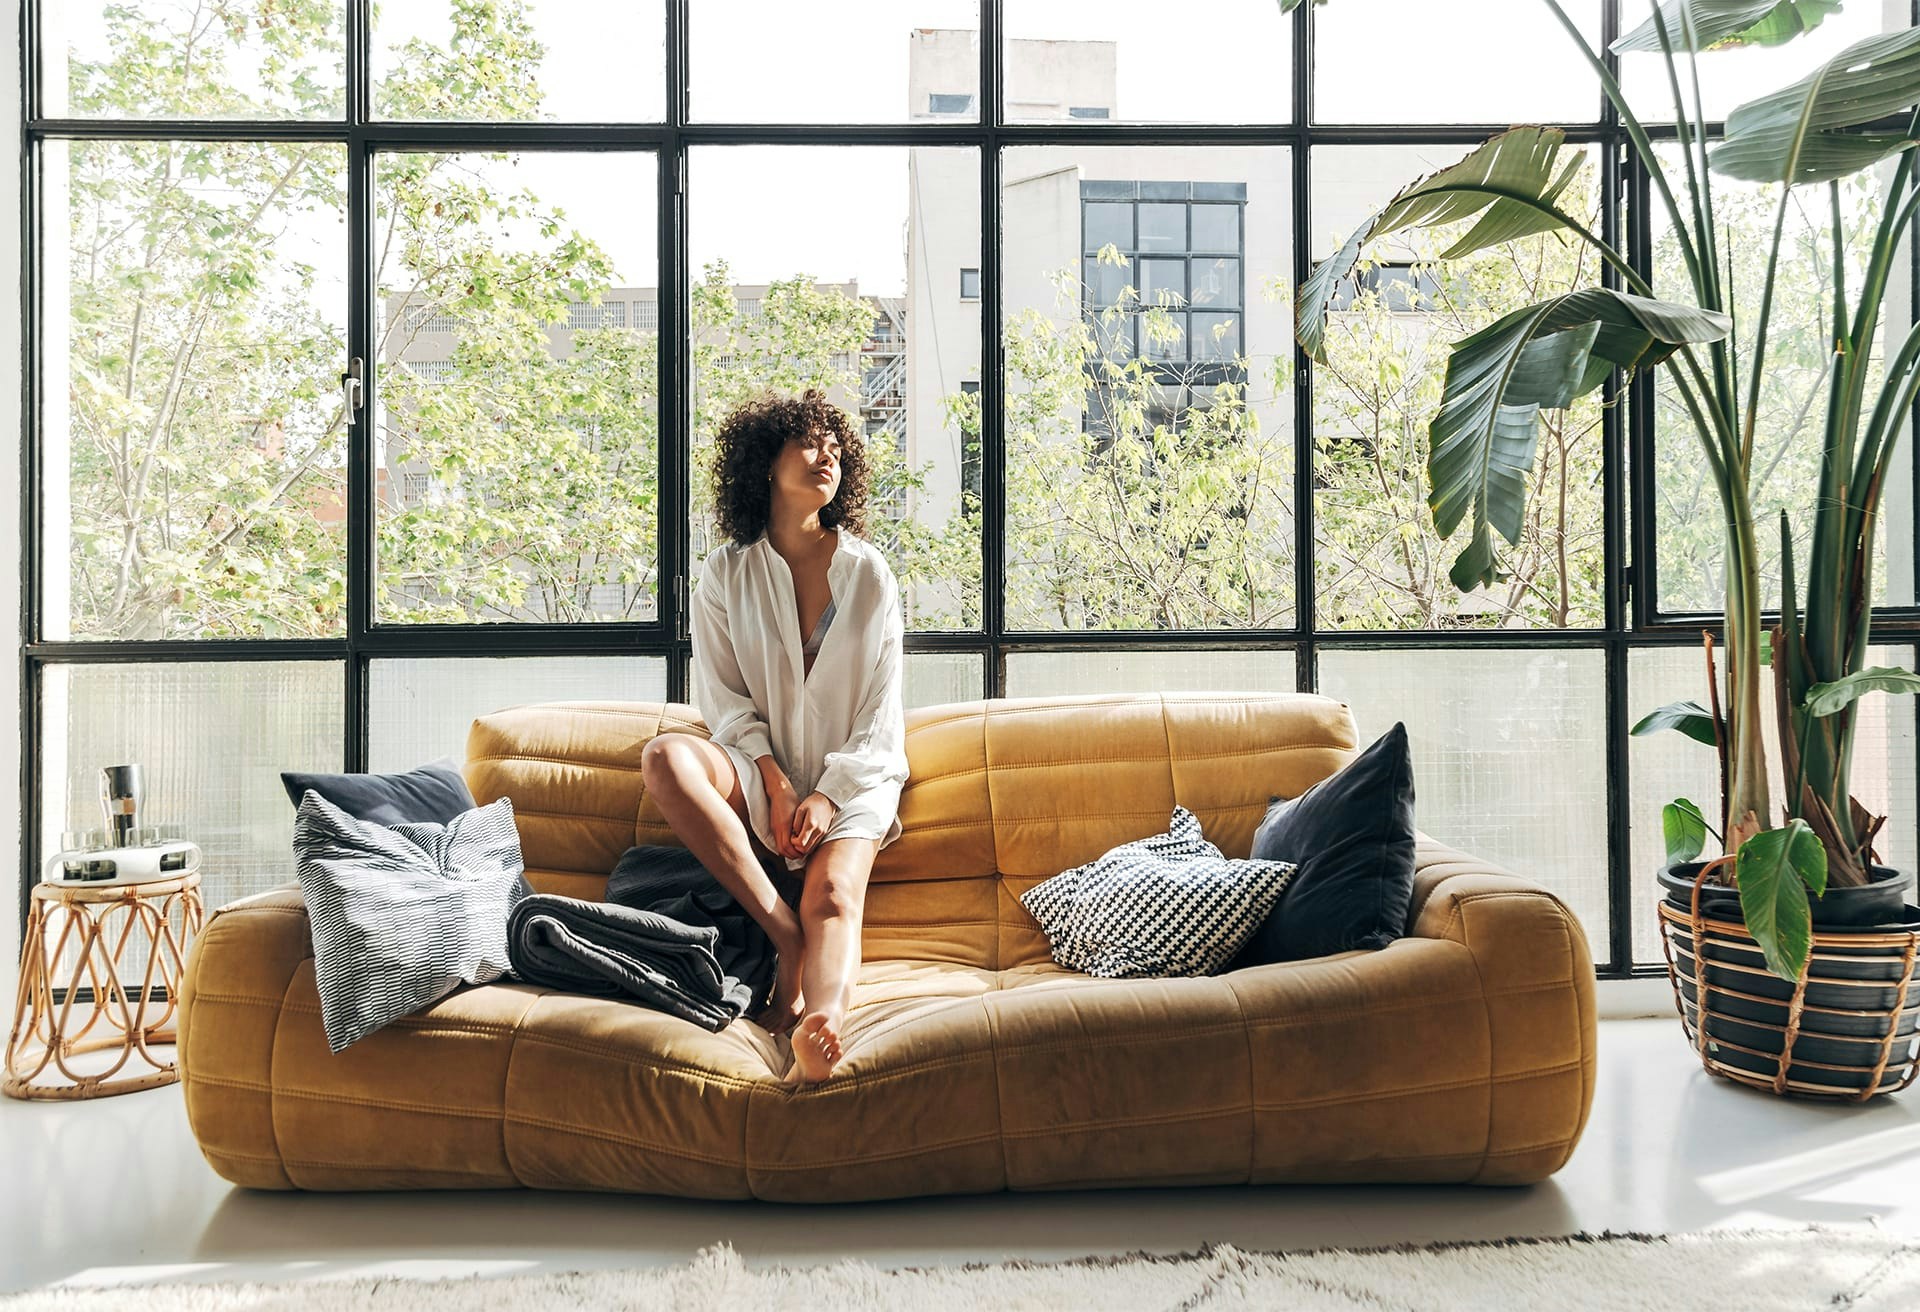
40,140,348,638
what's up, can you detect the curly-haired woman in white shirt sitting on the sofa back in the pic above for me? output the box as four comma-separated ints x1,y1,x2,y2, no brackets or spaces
641,388,906,1081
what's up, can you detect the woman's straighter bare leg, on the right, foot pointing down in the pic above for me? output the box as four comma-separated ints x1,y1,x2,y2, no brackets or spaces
787,838,879,1081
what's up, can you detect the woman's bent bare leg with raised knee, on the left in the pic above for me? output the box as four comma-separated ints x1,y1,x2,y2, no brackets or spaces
639,732,806,1033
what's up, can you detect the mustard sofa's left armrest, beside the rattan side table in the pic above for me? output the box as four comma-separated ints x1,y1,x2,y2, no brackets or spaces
175,884,313,1189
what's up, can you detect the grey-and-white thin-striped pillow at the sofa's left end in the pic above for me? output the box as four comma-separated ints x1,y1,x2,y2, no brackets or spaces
294,788,534,1053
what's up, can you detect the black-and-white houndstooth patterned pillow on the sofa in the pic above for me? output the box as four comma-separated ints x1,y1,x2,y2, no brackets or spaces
1020,807,1294,980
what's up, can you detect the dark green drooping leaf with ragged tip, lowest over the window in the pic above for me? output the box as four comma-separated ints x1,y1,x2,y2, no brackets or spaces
1427,288,1732,592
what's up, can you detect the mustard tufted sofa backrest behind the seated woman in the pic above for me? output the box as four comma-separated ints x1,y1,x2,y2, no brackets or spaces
465,692,1356,970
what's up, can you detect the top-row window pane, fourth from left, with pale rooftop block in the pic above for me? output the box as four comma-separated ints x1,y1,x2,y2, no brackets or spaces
1004,0,1294,123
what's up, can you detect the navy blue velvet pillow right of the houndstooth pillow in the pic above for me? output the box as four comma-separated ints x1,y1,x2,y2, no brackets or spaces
1225,724,1413,970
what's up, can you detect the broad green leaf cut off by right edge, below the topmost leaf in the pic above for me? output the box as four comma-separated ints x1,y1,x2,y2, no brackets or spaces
1709,27,1920,182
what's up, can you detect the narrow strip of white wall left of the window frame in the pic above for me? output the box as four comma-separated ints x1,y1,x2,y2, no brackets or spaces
0,0,25,1020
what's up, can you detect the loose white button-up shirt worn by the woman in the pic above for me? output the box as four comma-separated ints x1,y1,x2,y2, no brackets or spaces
691,526,906,870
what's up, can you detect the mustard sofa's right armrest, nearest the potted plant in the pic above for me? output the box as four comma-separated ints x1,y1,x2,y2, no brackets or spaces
1407,834,1599,1183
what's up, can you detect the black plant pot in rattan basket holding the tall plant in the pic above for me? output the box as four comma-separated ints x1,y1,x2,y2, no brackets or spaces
1659,863,1920,1099
